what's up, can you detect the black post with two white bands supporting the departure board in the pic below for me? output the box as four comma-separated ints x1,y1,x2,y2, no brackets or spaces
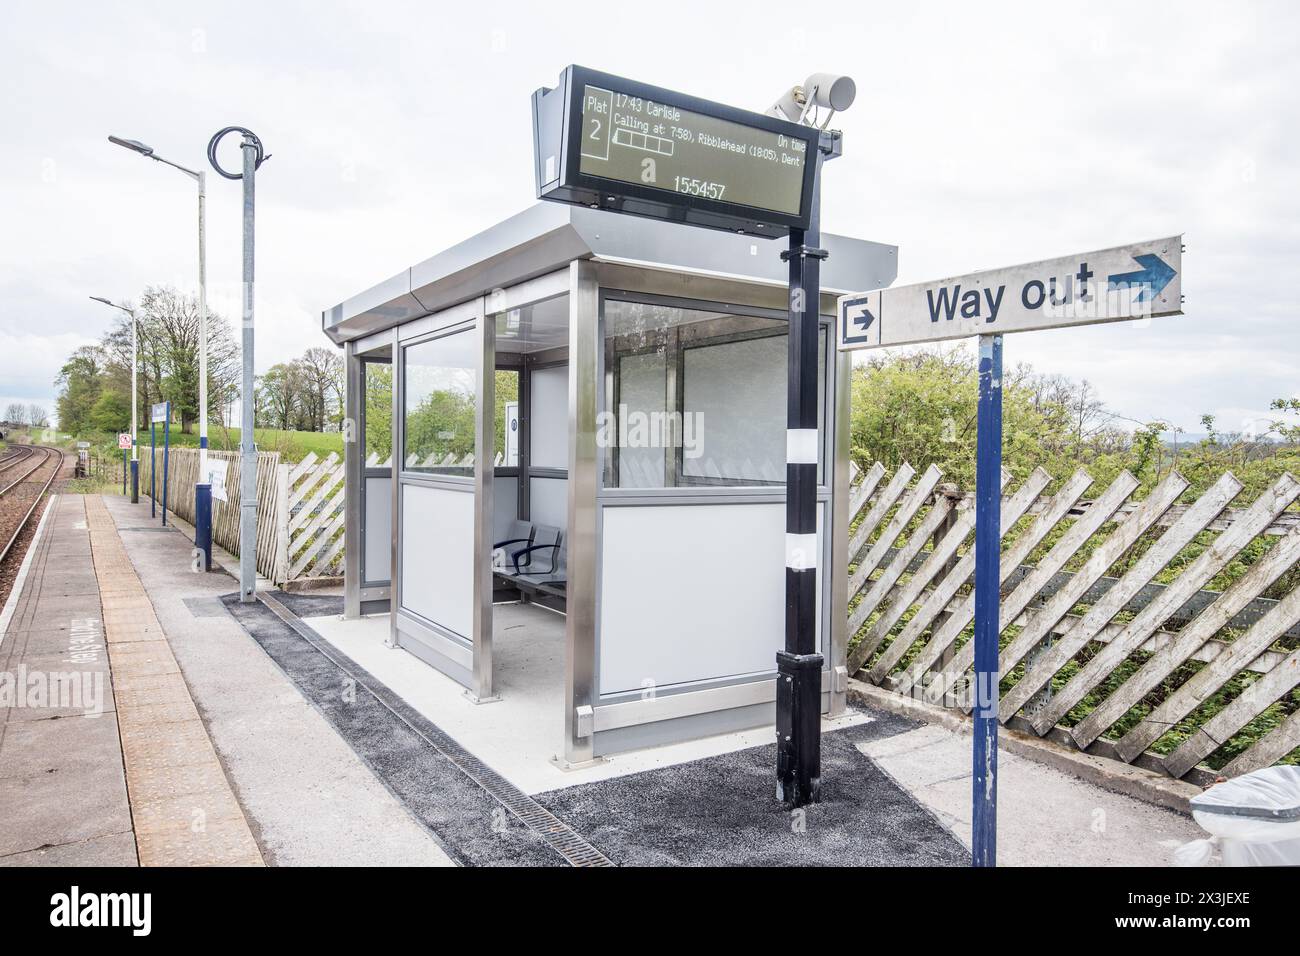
776,141,827,806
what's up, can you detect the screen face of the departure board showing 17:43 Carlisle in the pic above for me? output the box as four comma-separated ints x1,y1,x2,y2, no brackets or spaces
579,86,807,216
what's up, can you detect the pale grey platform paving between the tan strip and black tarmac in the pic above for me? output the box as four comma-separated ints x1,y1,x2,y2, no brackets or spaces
104,496,451,866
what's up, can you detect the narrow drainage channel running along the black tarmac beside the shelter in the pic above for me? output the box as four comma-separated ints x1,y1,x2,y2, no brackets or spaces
257,592,614,866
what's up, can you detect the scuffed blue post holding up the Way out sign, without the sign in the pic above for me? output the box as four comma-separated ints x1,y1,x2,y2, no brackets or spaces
971,336,1002,866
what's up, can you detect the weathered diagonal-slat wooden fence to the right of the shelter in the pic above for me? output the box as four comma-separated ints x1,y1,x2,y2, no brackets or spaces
849,463,1300,782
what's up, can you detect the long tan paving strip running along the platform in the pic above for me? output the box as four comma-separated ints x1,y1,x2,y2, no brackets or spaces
86,496,264,866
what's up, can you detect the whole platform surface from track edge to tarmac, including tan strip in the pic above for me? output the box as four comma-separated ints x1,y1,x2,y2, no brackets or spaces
0,496,451,866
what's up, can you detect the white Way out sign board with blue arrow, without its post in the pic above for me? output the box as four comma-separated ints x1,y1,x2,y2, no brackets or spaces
840,235,1183,350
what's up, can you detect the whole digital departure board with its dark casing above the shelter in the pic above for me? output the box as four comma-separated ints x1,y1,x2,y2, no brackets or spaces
533,66,819,238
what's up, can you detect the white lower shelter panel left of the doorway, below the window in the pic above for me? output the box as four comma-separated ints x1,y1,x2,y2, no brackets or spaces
402,485,475,639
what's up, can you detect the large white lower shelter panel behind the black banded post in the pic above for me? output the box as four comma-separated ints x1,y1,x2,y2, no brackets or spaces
599,503,824,696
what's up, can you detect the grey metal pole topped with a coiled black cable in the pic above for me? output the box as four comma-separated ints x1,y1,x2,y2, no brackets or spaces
208,126,270,604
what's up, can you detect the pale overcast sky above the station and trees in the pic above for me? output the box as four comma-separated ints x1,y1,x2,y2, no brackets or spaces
0,0,1300,431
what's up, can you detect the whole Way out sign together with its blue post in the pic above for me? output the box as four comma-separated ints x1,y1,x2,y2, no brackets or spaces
839,235,1183,866
